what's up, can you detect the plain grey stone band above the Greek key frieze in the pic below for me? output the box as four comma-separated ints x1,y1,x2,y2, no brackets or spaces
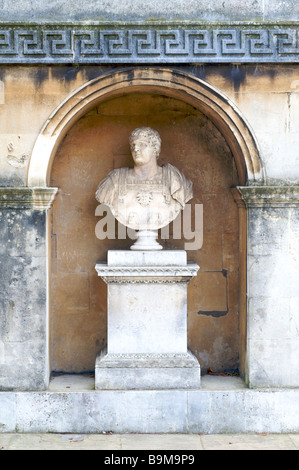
0,0,299,22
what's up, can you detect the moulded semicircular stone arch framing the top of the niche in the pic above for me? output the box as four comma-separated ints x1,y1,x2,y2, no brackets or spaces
27,68,264,187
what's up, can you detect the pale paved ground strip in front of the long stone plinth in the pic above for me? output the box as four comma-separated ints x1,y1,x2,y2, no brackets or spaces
0,432,299,450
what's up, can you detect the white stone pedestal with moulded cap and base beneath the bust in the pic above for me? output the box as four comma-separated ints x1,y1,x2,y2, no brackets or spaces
95,251,200,390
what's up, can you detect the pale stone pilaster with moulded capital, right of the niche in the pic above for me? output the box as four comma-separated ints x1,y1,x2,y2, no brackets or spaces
238,186,299,388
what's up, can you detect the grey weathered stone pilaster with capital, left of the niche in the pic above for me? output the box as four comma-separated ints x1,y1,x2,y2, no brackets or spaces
0,188,57,390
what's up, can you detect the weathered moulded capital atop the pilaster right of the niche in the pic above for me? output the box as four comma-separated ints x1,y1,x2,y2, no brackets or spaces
237,186,299,208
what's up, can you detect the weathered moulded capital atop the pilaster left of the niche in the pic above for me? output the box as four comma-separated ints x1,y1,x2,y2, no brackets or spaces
0,187,58,210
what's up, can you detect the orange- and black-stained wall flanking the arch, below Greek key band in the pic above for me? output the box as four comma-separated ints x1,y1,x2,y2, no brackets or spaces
0,64,299,186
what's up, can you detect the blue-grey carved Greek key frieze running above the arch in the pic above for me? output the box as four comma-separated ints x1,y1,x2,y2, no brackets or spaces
0,22,299,64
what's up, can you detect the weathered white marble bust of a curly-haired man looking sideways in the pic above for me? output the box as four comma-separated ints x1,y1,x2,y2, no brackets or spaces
96,127,193,248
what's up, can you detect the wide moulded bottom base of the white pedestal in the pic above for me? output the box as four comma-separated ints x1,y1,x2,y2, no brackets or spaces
95,352,200,390
